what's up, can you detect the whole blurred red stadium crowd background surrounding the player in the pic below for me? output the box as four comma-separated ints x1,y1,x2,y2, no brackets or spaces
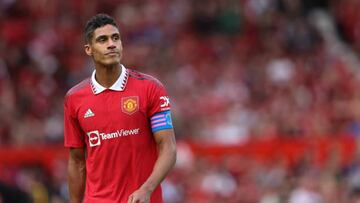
0,0,360,203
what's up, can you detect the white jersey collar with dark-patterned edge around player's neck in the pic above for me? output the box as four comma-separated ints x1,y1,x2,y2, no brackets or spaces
90,65,129,94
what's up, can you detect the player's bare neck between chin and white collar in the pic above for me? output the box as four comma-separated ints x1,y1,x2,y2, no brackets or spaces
95,64,121,88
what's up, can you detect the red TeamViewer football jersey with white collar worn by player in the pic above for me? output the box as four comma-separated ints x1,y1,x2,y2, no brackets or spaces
64,66,170,203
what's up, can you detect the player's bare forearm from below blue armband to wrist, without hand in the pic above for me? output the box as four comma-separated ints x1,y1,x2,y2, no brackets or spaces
141,137,176,192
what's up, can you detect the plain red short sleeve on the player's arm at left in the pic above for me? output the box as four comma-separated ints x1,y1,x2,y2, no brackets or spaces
64,96,85,147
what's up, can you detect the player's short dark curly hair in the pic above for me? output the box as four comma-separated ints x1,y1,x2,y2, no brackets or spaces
84,13,119,43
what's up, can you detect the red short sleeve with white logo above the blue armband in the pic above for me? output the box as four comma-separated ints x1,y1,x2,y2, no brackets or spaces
148,81,170,117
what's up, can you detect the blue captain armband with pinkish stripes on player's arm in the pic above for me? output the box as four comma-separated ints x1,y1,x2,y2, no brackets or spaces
150,111,173,133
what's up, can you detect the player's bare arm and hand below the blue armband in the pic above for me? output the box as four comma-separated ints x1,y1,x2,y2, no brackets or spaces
128,129,176,203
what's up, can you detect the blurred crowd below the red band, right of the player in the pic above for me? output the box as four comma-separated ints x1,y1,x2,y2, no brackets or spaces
163,141,360,203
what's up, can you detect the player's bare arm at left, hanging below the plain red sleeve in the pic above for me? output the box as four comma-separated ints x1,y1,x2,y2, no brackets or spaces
68,148,86,203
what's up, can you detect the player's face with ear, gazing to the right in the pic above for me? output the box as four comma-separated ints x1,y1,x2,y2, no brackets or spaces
85,25,123,66
